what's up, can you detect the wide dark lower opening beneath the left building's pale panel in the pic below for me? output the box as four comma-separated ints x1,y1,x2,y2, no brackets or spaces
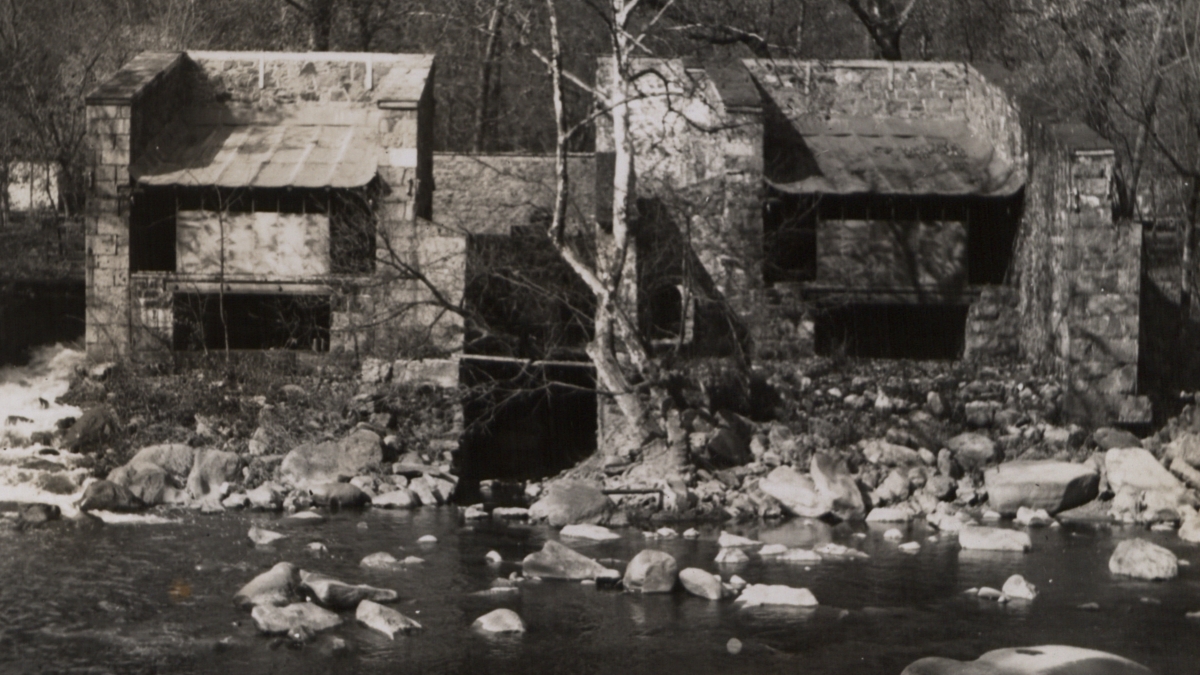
174,293,330,352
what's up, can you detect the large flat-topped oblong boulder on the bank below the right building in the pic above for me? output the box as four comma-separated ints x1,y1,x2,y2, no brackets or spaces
983,460,1100,515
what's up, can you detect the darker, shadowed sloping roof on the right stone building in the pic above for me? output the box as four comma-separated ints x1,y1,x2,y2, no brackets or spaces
767,119,1024,196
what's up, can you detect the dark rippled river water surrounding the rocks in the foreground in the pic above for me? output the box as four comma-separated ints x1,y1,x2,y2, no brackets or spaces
0,509,1200,675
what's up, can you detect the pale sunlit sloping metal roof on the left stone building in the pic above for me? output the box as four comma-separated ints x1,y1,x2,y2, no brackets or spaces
131,112,378,187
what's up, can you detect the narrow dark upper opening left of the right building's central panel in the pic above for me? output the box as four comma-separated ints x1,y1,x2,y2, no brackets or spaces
762,193,821,283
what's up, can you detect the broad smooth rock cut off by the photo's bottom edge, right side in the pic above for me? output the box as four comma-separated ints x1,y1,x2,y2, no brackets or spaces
900,645,1152,675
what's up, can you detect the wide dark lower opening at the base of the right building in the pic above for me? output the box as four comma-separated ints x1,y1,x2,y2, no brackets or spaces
815,304,967,359
